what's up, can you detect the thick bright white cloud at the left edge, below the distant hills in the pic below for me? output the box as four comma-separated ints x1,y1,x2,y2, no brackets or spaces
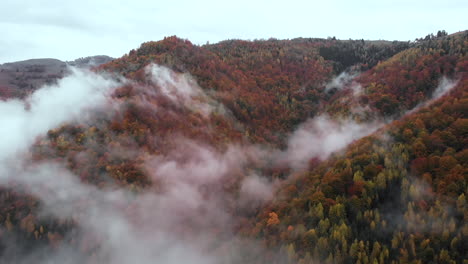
0,68,119,160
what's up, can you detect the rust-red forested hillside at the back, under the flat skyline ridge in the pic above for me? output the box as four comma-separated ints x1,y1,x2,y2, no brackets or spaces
103,37,409,143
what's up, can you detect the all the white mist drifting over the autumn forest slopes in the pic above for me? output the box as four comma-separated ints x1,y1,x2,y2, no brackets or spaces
0,65,455,264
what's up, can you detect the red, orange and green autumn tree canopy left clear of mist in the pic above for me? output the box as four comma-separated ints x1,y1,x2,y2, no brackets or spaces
0,32,468,263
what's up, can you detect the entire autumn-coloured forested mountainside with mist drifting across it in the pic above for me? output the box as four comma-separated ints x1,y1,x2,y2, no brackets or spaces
0,31,468,264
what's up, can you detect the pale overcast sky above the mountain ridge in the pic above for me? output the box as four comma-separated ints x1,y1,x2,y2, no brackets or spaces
0,0,468,63
